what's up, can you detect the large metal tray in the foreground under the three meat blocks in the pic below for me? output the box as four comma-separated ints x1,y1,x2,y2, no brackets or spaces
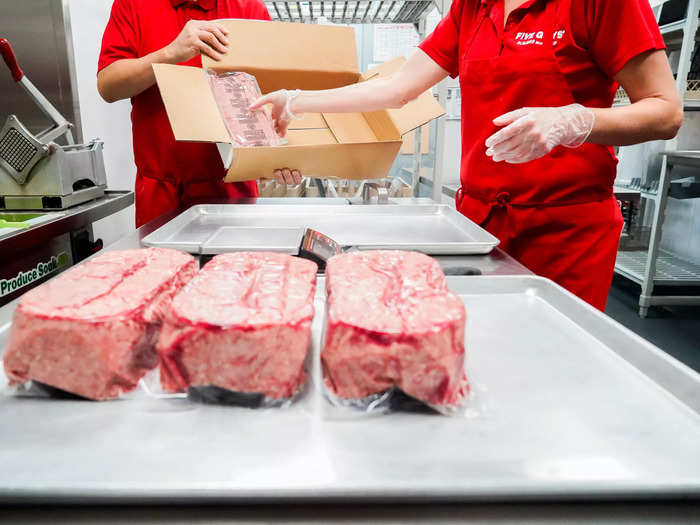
0,276,700,503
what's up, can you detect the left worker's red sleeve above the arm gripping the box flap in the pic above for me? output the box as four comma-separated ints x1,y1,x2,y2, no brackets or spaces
97,0,139,71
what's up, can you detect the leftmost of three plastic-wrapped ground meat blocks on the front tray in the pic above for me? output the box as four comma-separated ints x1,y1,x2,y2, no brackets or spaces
3,248,197,400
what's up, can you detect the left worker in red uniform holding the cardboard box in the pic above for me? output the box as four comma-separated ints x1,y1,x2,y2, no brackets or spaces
97,0,278,227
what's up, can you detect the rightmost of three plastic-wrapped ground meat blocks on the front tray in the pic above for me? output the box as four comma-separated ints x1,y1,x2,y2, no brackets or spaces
321,250,469,413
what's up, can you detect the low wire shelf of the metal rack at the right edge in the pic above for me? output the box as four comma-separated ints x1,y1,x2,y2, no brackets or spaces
615,250,700,285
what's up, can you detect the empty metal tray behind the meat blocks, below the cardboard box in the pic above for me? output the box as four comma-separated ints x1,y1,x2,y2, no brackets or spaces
143,204,499,255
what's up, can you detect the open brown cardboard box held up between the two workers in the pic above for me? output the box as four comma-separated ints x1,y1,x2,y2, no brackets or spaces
153,20,444,182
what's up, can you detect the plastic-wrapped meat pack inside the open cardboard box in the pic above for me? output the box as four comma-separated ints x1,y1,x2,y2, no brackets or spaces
207,69,286,146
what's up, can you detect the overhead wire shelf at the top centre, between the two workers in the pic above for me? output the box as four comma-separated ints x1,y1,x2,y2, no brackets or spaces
265,0,434,24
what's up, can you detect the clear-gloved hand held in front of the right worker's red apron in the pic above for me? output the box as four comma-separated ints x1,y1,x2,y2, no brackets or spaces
486,104,595,164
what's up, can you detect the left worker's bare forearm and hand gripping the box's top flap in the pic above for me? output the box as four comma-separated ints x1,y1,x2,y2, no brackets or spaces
97,20,228,102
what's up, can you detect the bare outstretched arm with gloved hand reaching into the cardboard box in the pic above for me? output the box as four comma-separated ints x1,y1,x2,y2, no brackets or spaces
251,49,447,136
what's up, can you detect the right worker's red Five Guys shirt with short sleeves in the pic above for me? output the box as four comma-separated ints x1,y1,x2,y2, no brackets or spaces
420,0,665,107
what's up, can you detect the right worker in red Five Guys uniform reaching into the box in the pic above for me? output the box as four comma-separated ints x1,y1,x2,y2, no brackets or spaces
252,0,683,310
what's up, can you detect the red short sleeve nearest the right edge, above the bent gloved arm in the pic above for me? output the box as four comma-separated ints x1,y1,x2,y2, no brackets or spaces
572,0,666,78
